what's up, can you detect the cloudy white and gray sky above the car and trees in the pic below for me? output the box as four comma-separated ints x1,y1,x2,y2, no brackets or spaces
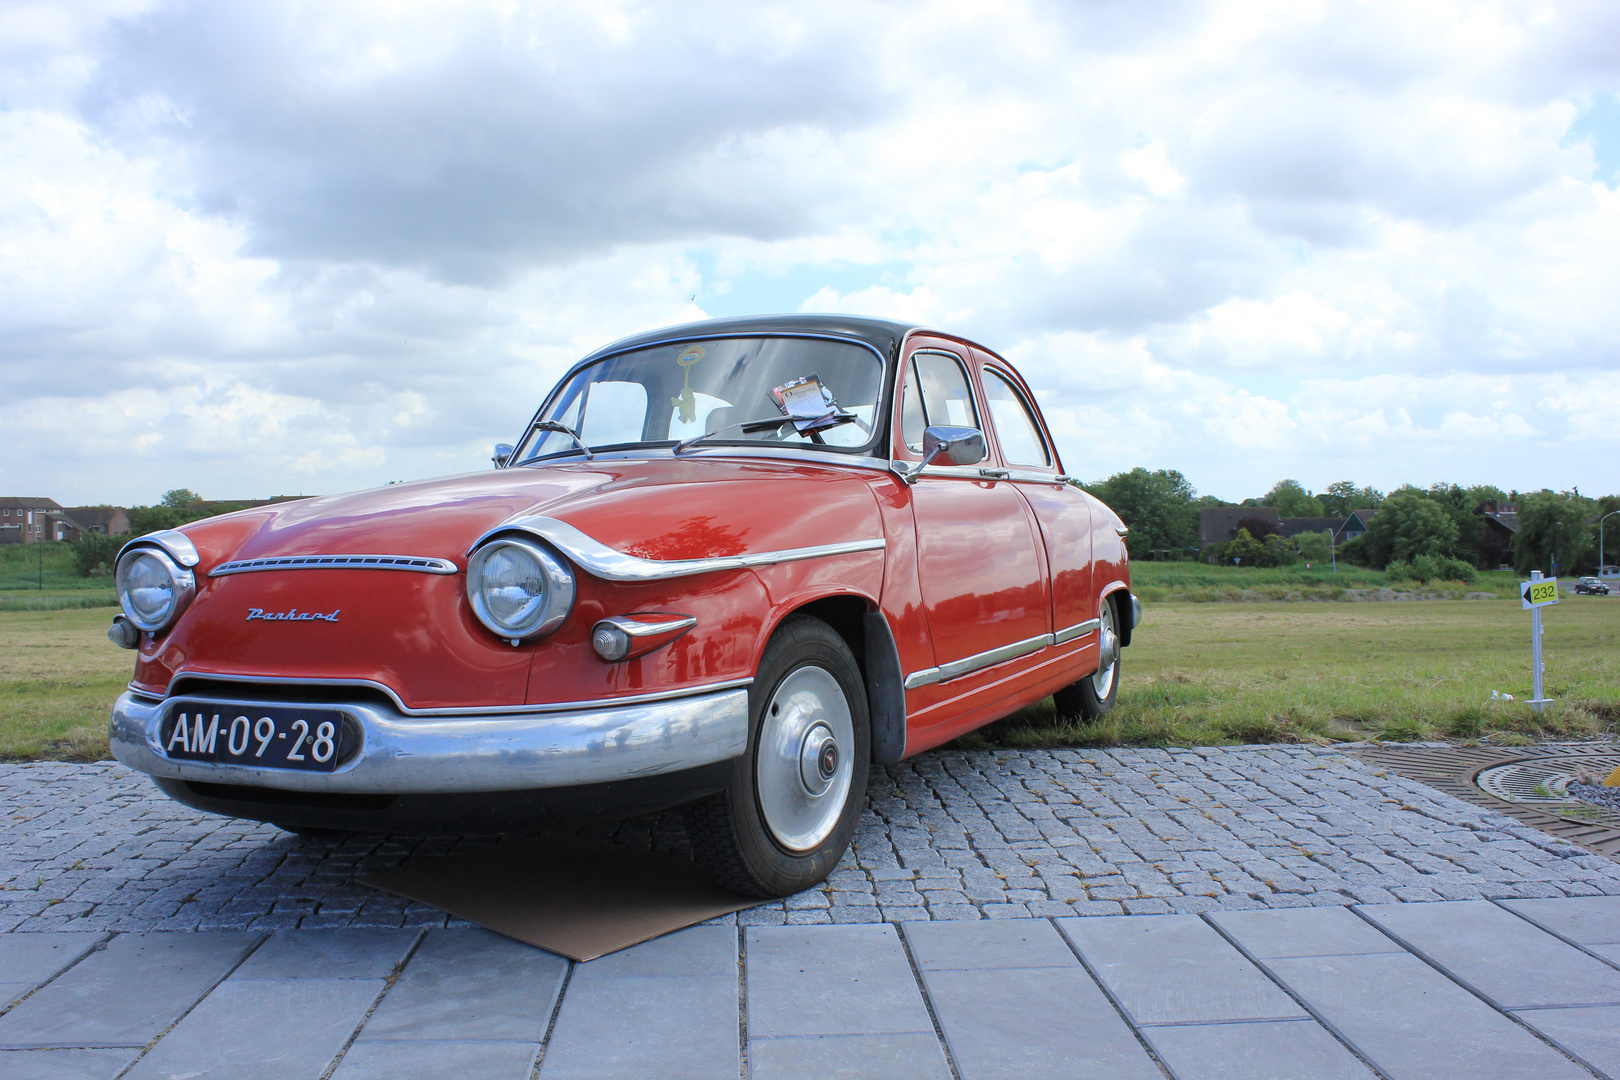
0,0,1620,505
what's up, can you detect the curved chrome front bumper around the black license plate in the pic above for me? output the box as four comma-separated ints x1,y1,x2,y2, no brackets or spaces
109,690,748,795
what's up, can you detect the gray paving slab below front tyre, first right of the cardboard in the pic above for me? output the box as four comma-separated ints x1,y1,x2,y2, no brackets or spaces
745,925,933,1046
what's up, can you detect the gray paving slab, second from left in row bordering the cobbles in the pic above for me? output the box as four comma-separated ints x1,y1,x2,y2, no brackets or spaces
0,934,259,1048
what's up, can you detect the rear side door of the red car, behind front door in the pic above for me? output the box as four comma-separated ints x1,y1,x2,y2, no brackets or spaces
977,355,1098,674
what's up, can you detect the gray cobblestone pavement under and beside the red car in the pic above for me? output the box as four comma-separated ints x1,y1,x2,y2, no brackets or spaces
0,746,1620,931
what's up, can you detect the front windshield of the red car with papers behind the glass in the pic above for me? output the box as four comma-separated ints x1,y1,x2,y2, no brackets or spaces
512,337,883,465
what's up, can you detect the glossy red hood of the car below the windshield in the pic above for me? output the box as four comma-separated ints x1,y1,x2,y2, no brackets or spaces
183,458,881,572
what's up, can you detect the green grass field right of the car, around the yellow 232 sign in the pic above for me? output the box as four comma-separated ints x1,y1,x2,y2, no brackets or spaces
954,597,1620,746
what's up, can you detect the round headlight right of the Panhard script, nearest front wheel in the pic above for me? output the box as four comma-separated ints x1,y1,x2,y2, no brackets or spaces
467,536,573,644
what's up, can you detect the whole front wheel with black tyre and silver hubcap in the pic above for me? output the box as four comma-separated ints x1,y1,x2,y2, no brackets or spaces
685,615,872,897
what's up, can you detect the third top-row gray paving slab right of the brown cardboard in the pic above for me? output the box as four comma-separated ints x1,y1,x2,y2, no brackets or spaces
1058,915,1307,1023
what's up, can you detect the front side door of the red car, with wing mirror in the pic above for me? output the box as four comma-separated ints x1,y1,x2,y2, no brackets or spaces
896,342,1051,703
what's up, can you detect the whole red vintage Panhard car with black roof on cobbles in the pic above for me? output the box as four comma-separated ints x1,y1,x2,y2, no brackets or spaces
109,316,1140,895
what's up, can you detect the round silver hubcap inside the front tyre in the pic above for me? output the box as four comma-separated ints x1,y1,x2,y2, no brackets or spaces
753,665,855,852
